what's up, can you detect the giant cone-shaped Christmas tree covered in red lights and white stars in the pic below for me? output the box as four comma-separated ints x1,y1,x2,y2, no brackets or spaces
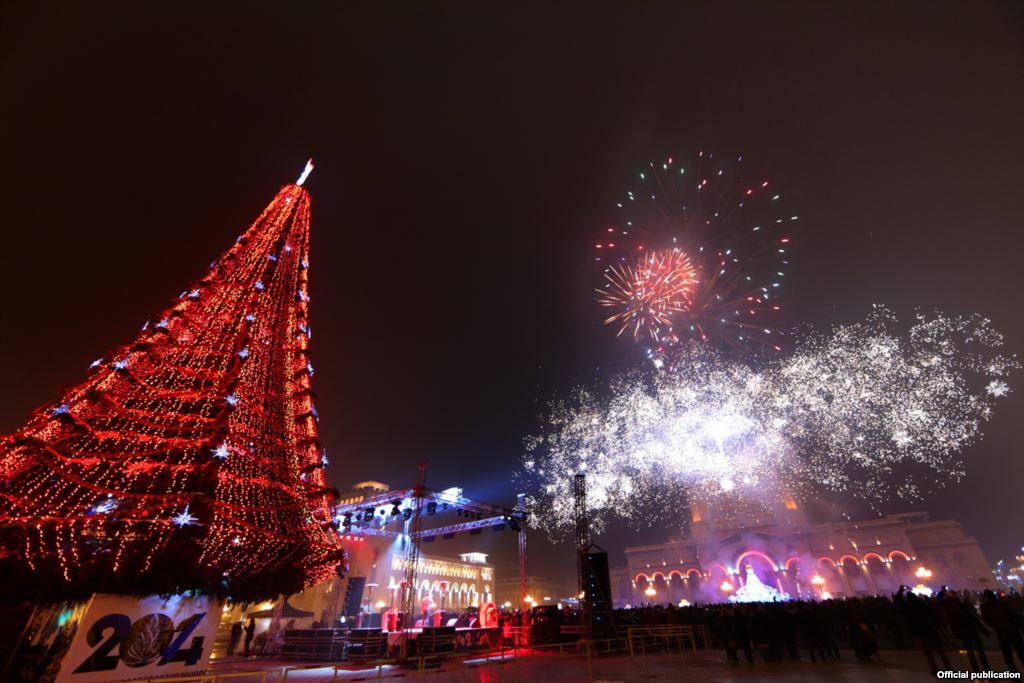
0,164,343,599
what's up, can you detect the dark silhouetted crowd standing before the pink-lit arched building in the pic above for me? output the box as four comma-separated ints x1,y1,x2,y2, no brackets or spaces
614,587,1024,673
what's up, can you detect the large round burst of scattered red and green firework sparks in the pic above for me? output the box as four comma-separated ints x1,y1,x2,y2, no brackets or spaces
595,152,798,352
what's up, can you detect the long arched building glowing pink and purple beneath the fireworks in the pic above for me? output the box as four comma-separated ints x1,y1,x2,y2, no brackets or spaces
612,498,995,607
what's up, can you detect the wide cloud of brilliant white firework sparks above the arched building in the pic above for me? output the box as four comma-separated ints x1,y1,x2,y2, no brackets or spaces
523,307,1018,532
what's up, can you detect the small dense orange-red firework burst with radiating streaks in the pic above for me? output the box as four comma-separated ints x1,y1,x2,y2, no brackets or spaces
597,248,696,342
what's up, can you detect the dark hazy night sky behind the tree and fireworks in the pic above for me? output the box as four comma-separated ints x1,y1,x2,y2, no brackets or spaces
0,2,1024,586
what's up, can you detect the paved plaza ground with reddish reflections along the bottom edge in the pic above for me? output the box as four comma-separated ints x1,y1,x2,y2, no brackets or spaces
201,650,1015,683
